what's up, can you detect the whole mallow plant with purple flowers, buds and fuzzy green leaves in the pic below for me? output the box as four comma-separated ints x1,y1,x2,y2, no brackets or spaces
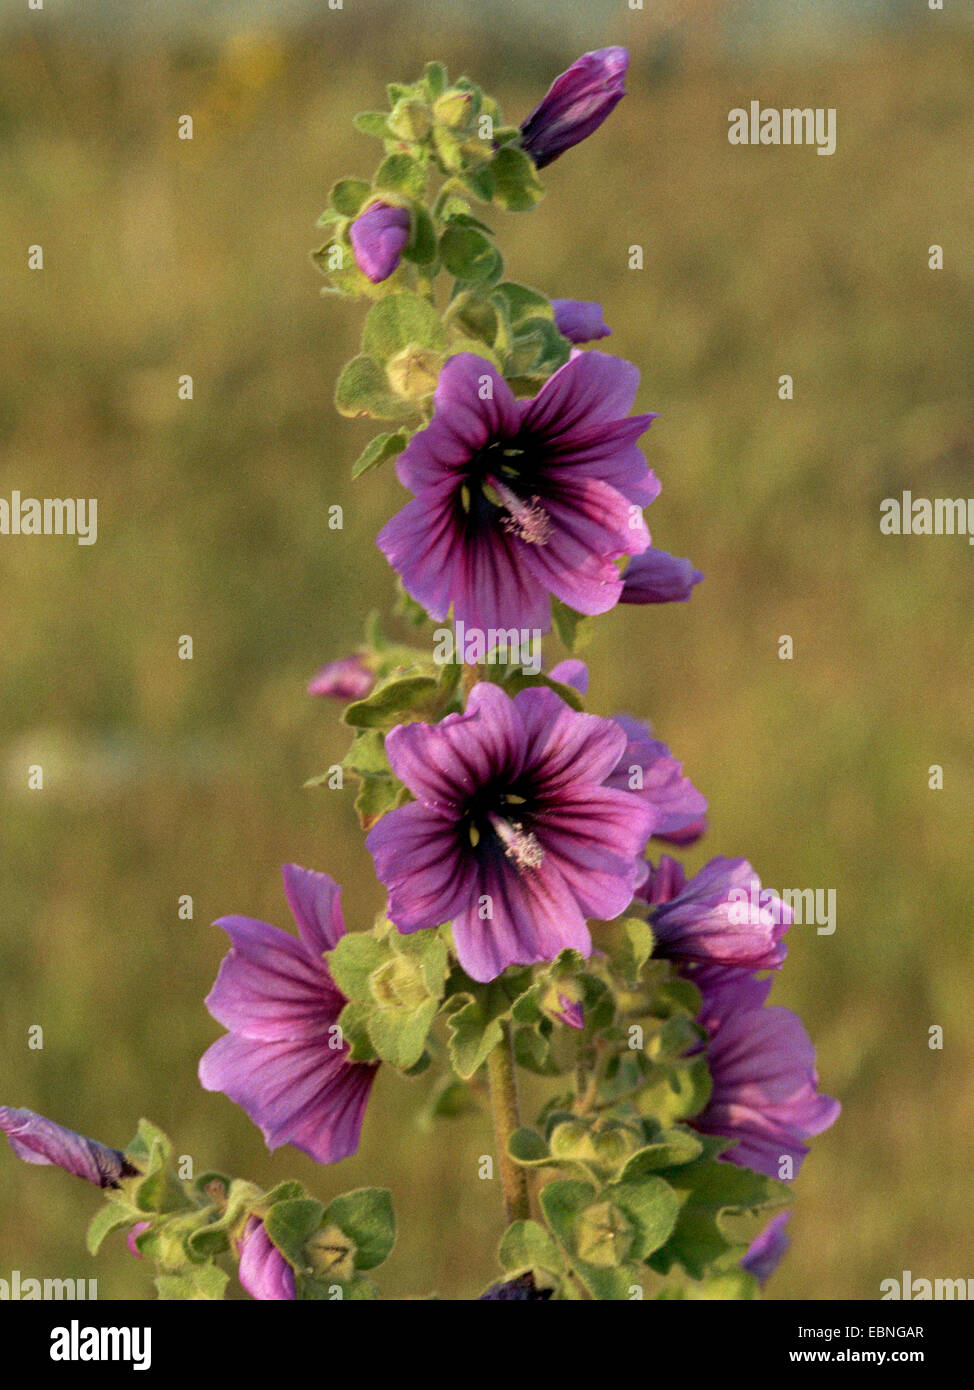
0,49,838,1301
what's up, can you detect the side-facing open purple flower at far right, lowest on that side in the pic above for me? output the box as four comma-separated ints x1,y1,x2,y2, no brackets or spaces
688,966,841,1177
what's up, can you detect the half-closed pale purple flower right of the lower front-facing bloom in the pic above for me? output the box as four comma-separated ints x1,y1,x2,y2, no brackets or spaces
642,856,793,970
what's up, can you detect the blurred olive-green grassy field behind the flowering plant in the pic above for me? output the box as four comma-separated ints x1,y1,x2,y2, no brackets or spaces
0,0,974,1298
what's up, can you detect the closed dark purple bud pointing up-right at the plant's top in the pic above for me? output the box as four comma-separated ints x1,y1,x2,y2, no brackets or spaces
521,49,629,170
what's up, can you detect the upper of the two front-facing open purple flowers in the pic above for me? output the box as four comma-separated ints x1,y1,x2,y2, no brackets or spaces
378,352,660,631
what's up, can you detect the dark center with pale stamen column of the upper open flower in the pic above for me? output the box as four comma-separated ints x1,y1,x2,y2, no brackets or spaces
457,435,552,545
